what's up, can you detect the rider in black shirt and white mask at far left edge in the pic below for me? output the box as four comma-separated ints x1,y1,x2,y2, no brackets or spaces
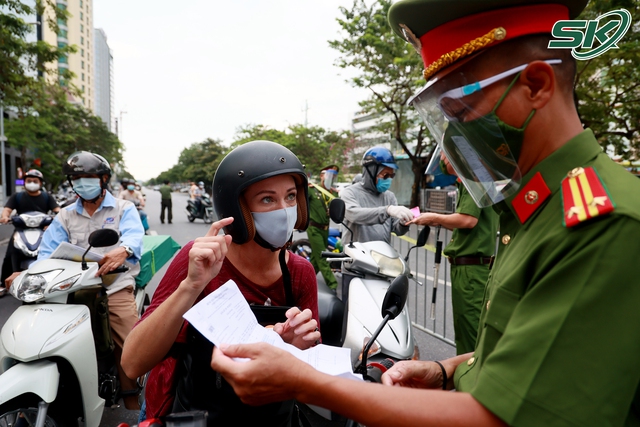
0,169,60,297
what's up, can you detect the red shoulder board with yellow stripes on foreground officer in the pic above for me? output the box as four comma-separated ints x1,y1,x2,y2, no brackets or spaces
562,167,615,228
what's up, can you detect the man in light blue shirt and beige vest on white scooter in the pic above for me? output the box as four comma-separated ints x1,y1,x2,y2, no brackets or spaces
38,151,144,409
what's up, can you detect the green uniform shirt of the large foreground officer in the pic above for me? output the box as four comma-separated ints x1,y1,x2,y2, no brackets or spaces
455,130,640,426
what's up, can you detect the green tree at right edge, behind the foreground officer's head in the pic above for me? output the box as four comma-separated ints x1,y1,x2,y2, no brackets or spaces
575,0,640,160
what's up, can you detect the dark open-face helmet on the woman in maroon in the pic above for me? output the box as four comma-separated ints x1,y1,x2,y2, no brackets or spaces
213,141,309,244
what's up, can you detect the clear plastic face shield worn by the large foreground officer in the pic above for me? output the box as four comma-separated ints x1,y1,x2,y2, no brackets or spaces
409,60,561,207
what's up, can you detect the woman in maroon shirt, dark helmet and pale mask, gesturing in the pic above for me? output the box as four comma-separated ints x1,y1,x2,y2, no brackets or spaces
122,141,320,426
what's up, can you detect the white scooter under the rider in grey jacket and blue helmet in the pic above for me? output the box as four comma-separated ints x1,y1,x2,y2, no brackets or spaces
307,199,429,425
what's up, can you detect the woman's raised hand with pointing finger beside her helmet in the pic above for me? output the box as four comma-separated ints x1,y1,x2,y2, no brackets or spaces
181,217,233,293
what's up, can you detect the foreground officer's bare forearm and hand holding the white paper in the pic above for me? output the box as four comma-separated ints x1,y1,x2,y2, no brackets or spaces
211,343,505,427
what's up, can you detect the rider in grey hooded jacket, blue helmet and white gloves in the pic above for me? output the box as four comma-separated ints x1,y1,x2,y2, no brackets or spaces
340,147,413,243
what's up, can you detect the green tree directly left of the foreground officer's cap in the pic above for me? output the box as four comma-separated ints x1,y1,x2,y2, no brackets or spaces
329,0,431,206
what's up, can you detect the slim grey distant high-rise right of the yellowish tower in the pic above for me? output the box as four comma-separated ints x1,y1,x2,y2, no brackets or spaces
93,28,113,131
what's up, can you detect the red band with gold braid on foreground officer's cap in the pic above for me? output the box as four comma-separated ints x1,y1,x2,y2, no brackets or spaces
414,4,569,79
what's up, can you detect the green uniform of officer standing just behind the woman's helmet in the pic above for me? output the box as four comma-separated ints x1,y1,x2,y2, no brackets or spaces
307,186,338,289
